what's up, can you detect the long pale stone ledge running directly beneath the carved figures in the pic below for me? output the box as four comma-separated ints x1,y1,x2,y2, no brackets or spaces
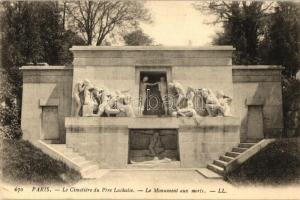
65,117,240,129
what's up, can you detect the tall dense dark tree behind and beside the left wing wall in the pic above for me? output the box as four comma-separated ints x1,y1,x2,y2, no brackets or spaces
0,1,83,139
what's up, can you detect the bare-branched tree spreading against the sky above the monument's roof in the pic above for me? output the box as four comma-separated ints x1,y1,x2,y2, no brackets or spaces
67,0,151,45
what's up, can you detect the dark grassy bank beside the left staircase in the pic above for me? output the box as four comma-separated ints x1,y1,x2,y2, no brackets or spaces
1,140,81,184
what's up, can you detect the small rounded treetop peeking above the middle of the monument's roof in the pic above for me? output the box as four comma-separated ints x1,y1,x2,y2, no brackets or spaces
123,29,153,46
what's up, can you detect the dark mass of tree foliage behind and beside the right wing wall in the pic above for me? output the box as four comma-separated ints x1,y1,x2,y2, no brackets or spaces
195,1,300,135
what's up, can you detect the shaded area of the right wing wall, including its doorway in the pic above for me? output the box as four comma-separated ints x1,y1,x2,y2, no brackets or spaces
241,82,283,142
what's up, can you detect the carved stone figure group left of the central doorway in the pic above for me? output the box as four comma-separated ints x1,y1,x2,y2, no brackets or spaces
73,80,134,117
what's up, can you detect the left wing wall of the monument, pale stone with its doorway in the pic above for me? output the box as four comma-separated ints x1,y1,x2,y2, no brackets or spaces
21,66,73,142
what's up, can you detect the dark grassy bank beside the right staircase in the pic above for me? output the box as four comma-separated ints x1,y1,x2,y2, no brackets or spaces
227,140,300,186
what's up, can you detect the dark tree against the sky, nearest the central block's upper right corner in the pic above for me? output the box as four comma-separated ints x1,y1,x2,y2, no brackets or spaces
195,1,272,65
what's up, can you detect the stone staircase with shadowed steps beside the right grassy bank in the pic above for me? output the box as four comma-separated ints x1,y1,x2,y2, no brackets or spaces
207,139,275,176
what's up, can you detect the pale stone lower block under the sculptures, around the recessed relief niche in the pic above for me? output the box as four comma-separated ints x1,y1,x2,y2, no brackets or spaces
65,117,240,168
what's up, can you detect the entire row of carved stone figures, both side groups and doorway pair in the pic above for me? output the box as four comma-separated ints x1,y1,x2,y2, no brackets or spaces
73,79,232,117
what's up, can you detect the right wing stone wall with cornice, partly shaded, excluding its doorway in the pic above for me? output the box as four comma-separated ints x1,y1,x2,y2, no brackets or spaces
232,66,283,140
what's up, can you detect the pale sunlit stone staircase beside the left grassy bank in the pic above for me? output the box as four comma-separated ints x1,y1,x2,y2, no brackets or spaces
39,141,101,178
